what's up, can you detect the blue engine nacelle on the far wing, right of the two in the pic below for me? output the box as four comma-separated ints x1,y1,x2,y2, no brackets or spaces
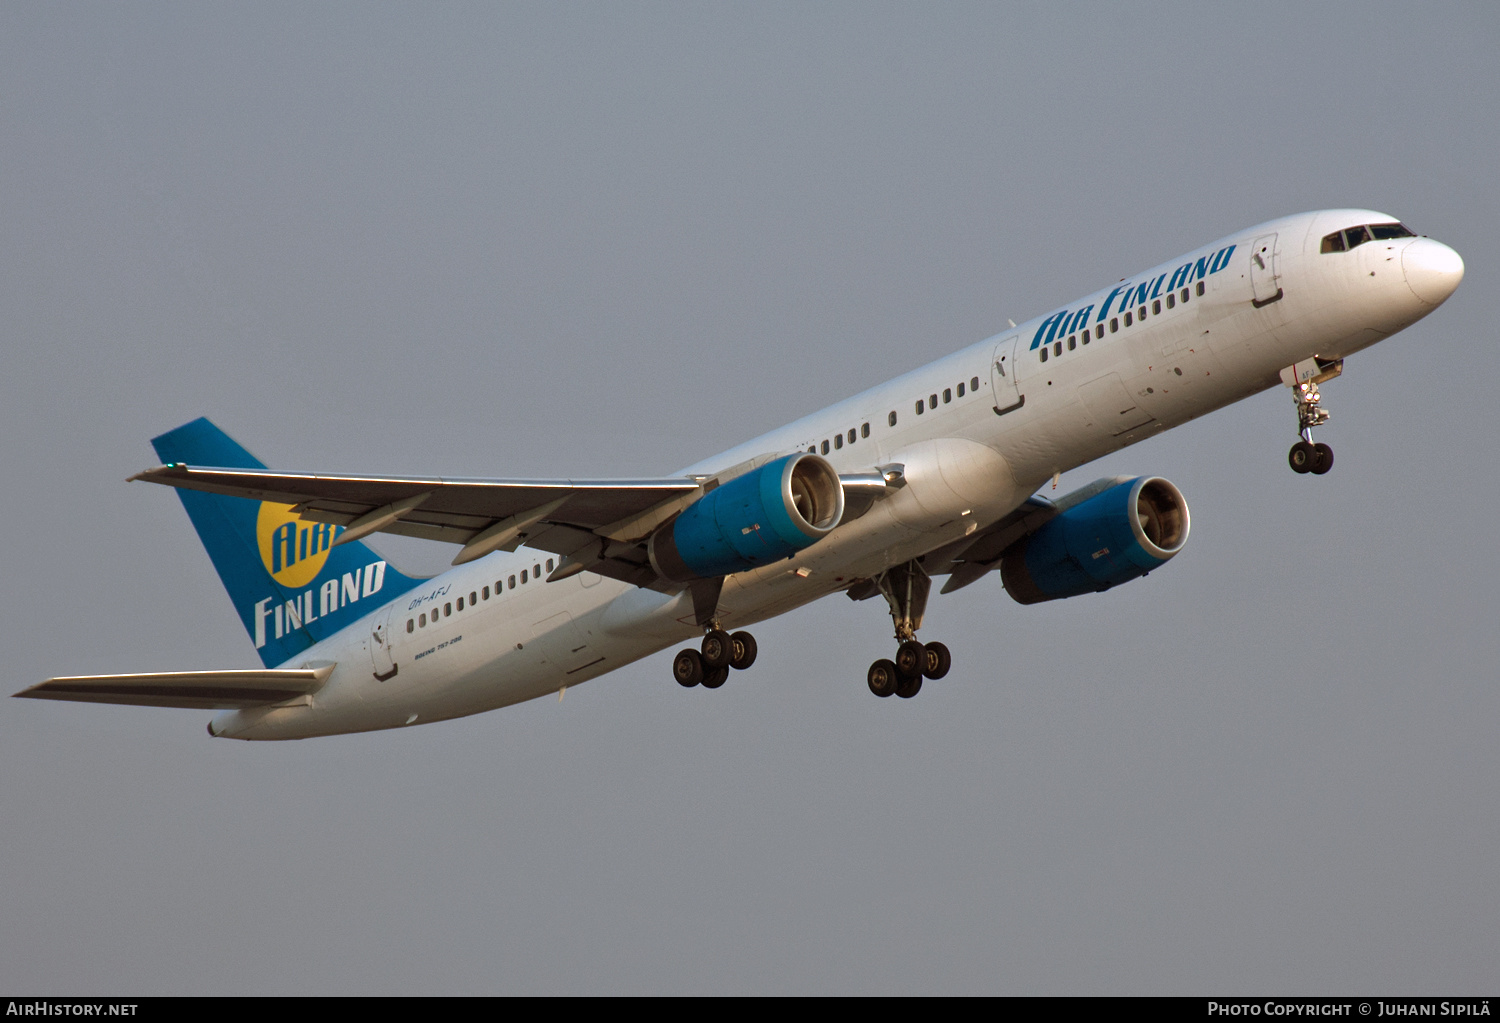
1001,476,1190,605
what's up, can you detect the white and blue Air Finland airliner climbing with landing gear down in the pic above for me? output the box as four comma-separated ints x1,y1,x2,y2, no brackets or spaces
15,210,1464,740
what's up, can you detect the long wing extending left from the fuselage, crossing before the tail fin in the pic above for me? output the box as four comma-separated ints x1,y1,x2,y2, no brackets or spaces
131,462,704,587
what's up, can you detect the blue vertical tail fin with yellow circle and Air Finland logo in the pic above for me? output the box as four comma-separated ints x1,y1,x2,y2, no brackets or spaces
152,419,420,668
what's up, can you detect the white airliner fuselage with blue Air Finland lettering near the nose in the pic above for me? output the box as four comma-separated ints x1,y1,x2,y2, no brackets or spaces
210,210,1461,740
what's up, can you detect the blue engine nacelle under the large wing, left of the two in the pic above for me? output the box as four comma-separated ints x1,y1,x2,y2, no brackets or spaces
647,452,845,582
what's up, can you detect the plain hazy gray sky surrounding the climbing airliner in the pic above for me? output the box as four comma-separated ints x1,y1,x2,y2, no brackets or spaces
0,3,1500,995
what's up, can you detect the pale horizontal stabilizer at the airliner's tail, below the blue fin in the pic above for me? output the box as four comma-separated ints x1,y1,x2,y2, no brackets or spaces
17,665,333,711
